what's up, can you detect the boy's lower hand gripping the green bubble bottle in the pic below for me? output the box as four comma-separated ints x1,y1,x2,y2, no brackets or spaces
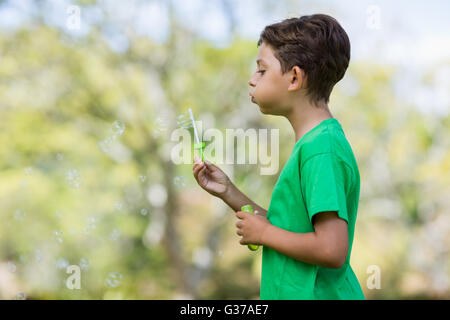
236,211,271,245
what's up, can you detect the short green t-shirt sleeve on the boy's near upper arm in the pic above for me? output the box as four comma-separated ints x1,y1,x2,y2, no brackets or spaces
300,152,352,223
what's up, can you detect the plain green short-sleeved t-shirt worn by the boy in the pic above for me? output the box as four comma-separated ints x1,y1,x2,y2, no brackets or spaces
260,118,364,300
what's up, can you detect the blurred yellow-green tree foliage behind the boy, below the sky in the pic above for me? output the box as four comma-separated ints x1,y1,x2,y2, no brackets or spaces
0,1,450,299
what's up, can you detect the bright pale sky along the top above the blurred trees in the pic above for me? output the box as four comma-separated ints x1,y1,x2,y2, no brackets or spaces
0,0,450,113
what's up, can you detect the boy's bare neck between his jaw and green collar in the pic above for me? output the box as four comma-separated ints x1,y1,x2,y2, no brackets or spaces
286,100,333,142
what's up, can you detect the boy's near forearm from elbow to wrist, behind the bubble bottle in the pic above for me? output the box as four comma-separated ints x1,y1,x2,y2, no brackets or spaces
261,225,337,268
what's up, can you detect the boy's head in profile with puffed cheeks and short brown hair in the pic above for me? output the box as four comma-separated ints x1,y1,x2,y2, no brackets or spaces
249,14,350,115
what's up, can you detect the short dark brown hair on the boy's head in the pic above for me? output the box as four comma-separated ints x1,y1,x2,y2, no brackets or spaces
258,14,350,103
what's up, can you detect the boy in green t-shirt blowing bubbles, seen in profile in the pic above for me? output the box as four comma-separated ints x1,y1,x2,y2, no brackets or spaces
193,14,364,299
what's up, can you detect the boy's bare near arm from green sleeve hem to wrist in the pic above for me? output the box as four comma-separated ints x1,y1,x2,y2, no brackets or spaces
261,211,348,268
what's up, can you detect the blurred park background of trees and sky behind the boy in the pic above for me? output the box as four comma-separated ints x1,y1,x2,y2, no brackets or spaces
0,0,450,299
